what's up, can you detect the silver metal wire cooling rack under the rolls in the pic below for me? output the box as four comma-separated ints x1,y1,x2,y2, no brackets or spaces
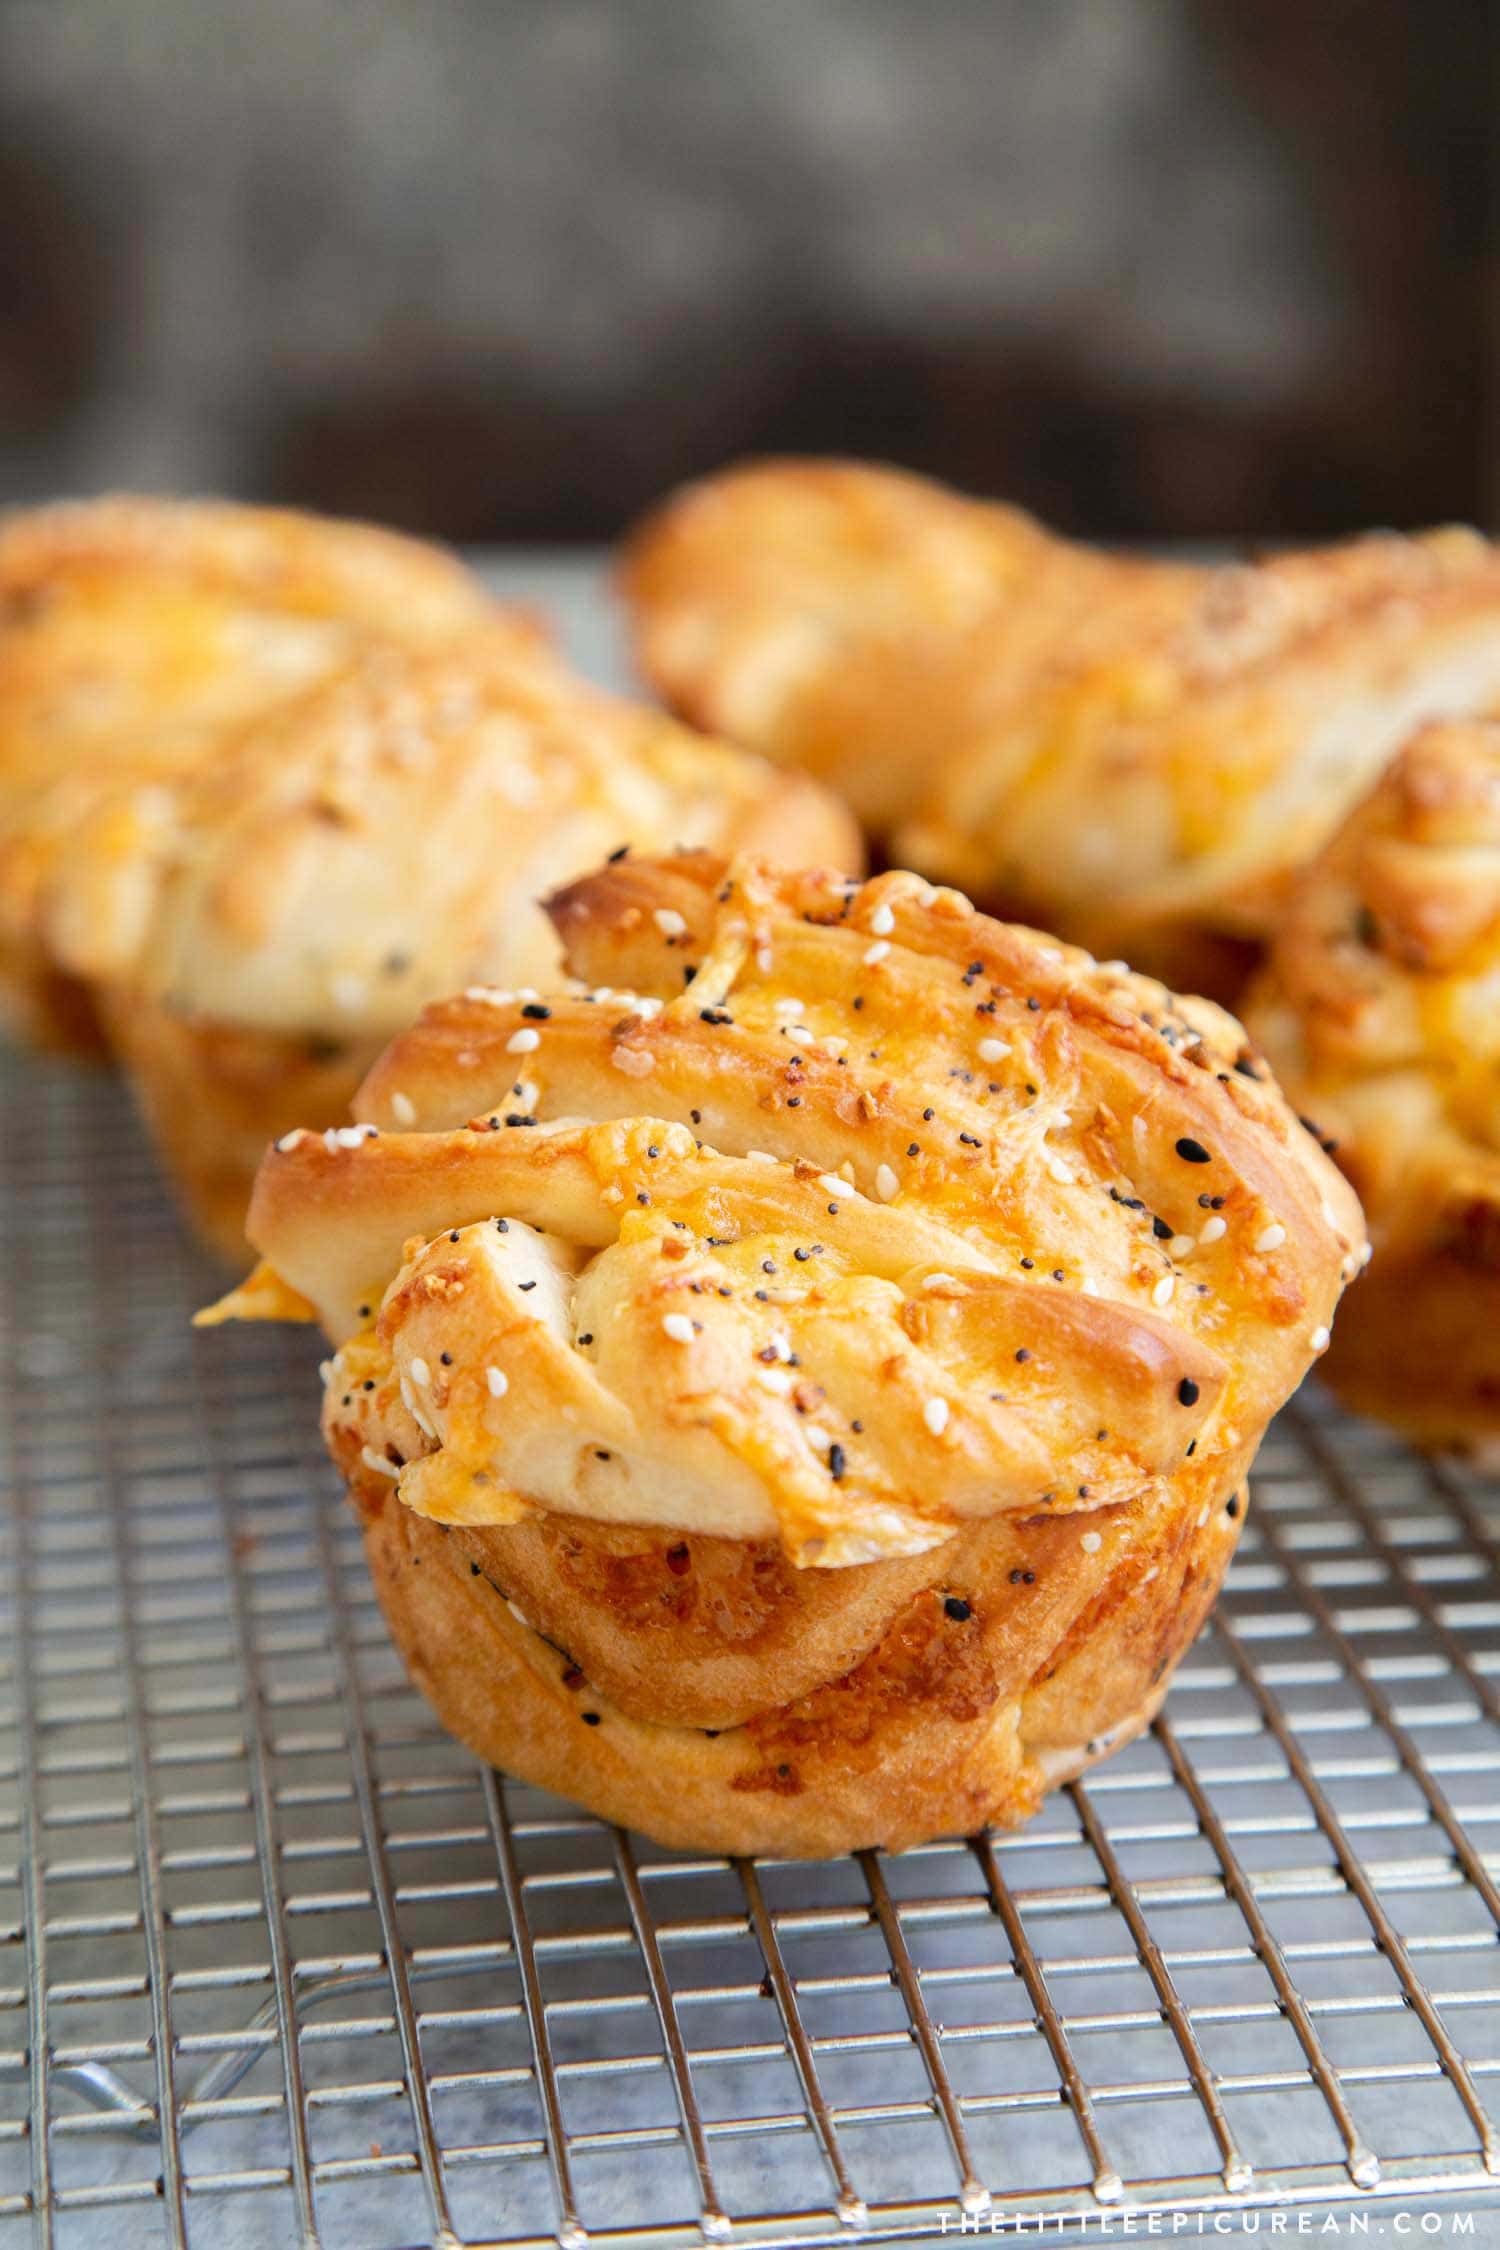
0,1044,1500,2250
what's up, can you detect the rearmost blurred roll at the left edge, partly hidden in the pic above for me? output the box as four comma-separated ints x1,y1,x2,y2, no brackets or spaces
0,497,495,1046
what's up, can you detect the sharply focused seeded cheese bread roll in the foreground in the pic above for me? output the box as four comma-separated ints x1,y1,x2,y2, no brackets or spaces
205,853,1363,1854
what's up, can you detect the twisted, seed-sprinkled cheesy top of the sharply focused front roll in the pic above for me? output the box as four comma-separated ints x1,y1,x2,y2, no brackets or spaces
231,853,1363,1564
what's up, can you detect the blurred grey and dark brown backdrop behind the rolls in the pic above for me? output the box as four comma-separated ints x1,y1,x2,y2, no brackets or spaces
0,0,1500,542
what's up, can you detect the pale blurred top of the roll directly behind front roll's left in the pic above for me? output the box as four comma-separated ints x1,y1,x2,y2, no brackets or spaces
118,623,859,1035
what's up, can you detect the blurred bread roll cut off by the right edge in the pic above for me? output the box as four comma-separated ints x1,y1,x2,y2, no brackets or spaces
1248,725,1500,1451
